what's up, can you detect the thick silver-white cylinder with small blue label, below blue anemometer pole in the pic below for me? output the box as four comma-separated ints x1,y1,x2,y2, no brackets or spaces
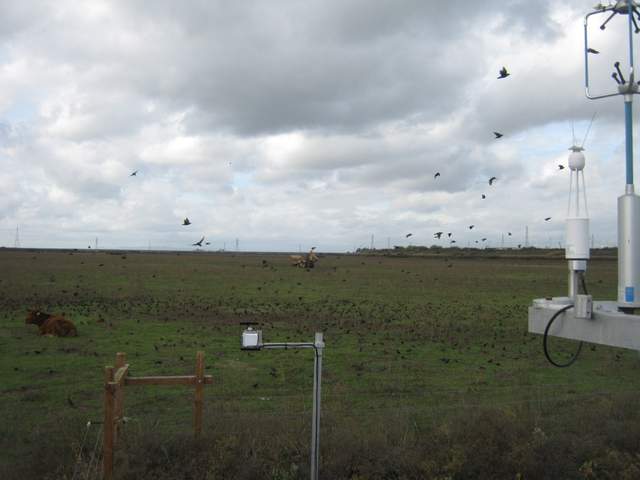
618,193,640,308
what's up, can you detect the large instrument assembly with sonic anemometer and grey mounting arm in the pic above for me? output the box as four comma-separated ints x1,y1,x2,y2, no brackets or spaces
529,0,640,367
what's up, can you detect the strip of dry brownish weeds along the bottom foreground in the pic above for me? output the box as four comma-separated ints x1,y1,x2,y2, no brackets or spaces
5,396,640,480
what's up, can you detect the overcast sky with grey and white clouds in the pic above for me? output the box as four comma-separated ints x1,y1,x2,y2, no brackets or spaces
0,0,640,251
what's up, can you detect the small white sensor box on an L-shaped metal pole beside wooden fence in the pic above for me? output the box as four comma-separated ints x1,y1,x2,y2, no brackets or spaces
241,322,324,480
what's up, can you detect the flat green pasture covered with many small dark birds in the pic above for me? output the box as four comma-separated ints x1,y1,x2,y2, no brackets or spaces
0,250,640,479
